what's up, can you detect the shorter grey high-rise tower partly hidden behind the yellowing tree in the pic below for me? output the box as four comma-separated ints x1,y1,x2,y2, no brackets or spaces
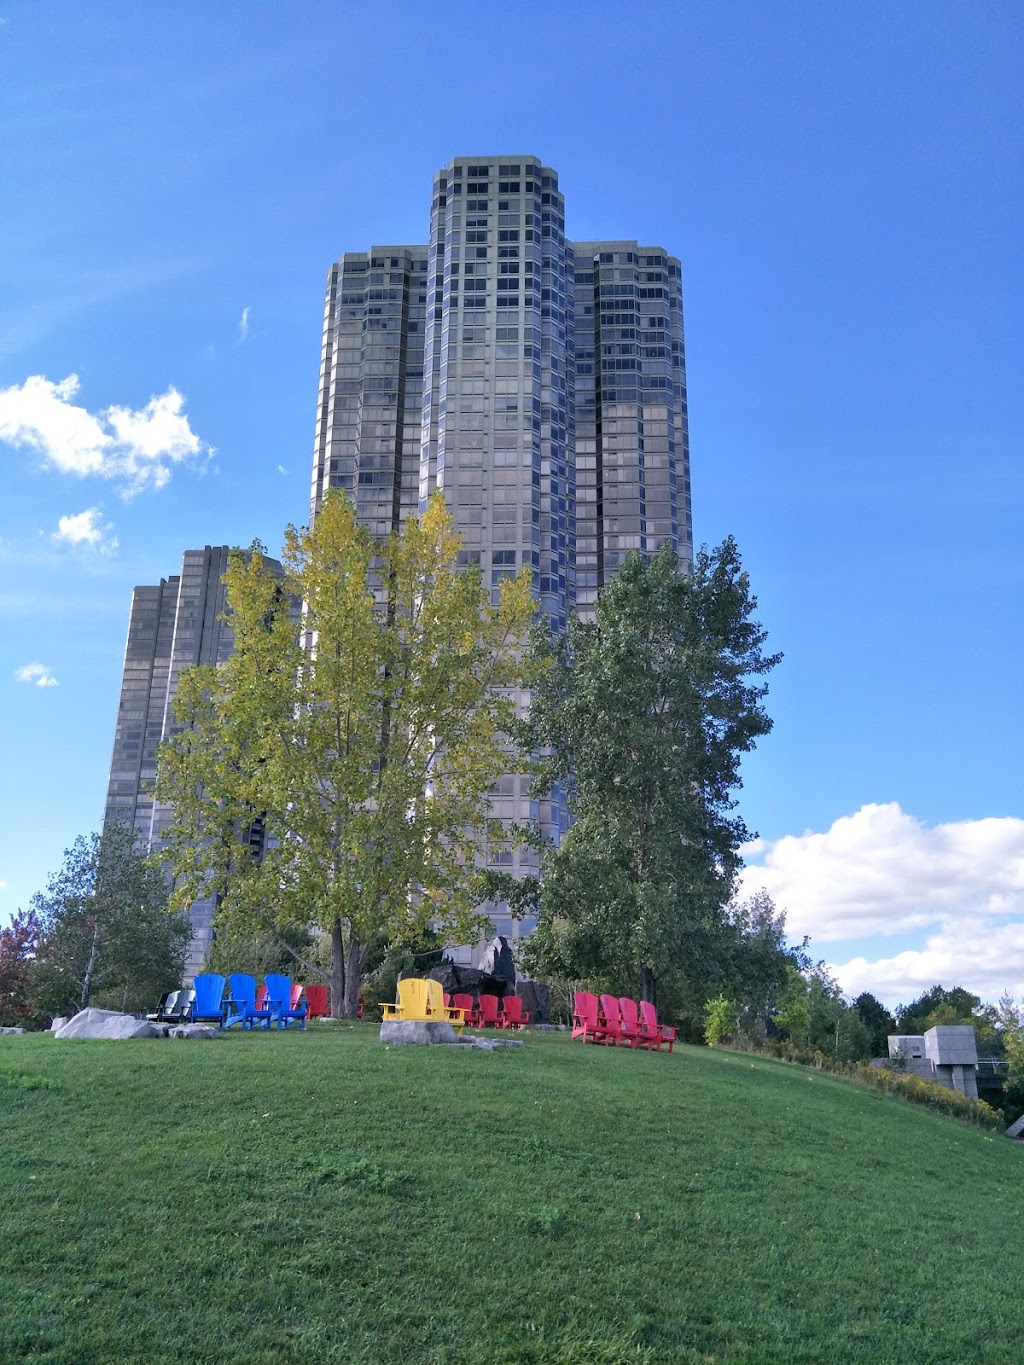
104,545,281,980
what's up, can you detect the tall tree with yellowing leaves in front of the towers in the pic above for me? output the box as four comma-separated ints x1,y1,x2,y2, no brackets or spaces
157,493,534,1017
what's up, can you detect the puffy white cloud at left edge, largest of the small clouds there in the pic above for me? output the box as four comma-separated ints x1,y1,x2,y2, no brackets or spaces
0,374,213,495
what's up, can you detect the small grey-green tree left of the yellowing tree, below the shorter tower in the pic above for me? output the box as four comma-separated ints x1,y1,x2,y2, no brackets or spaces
31,820,190,1014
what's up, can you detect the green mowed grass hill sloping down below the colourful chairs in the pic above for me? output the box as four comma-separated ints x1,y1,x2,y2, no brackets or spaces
0,1024,1024,1365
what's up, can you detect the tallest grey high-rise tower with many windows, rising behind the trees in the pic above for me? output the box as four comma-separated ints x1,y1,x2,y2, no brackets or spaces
310,154,692,961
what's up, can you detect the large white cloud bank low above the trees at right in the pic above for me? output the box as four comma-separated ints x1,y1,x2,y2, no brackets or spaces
741,801,1024,1003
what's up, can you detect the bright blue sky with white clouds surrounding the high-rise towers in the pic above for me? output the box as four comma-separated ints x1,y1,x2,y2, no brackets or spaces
0,0,1024,1001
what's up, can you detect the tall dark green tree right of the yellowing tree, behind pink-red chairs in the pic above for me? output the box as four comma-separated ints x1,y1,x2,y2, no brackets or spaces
527,538,780,1003
